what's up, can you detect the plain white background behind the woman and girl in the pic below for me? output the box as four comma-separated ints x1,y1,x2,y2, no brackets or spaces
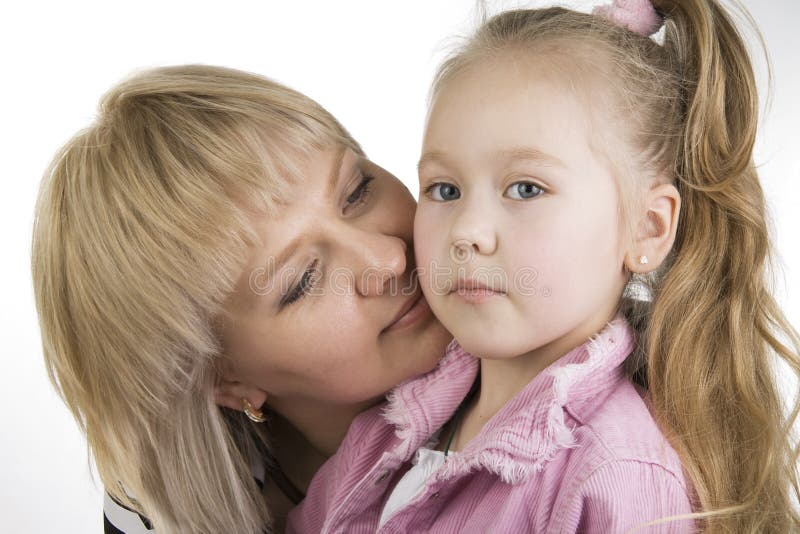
0,0,800,533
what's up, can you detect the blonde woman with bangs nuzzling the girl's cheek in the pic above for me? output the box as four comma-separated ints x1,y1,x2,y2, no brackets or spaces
32,66,450,533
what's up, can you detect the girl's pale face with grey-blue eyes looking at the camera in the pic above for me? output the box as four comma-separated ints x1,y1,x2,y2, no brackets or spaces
414,59,627,358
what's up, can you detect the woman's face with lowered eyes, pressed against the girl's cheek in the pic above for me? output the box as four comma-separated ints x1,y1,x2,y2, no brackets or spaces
223,148,451,406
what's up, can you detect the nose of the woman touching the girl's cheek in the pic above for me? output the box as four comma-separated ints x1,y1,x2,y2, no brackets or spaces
347,231,408,296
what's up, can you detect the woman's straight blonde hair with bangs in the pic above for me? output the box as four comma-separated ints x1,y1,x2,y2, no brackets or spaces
31,65,361,533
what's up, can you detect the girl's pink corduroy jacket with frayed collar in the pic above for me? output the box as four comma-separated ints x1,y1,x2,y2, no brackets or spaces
288,316,693,534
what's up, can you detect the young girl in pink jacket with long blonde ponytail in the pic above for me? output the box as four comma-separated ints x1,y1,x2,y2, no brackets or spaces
290,0,800,533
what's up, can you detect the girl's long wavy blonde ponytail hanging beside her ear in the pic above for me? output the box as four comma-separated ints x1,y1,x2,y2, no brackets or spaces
646,1,800,532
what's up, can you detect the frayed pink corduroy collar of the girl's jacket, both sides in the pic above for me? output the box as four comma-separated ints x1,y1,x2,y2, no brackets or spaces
384,315,635,484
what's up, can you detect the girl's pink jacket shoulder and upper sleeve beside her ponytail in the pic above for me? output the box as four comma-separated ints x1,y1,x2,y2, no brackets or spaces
551,380,694,532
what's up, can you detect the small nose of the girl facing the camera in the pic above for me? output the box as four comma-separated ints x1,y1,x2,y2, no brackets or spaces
450,202,497,263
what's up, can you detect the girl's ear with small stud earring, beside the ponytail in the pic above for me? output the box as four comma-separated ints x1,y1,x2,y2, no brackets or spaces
625,183,681,273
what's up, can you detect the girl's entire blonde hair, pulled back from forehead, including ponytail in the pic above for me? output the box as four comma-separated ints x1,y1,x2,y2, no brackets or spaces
431,0,800,532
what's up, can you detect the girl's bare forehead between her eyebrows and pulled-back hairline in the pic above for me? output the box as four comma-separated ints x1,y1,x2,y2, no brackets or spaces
420,56,619,172
